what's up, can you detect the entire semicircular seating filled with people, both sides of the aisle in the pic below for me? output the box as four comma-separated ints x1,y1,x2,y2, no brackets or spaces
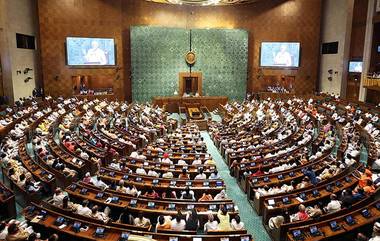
0,96,380,241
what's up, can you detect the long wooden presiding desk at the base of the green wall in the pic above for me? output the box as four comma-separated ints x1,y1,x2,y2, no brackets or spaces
152,96,228,112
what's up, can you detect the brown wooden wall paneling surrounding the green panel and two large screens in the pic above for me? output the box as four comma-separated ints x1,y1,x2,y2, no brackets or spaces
38,0,321,100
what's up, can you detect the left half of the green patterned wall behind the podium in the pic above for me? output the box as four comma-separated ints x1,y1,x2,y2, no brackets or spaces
131,27,189,102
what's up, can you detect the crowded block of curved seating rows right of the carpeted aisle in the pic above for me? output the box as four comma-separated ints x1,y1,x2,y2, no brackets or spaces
210,96,380,240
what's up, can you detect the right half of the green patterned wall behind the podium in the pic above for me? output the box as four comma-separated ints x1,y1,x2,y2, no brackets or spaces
191,29,248,100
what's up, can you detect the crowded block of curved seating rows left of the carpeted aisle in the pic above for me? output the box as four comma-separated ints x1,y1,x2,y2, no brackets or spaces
1,98,252,241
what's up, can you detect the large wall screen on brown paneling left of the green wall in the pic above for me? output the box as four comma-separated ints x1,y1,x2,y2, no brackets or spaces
66,37,116,67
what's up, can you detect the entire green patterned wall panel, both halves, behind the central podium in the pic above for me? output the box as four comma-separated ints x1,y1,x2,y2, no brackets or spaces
131,26,248,102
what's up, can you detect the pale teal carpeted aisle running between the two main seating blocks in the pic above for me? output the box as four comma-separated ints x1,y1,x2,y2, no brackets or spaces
201,131,271,241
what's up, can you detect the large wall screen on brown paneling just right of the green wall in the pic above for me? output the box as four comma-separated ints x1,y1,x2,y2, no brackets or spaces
260,42,301,68
